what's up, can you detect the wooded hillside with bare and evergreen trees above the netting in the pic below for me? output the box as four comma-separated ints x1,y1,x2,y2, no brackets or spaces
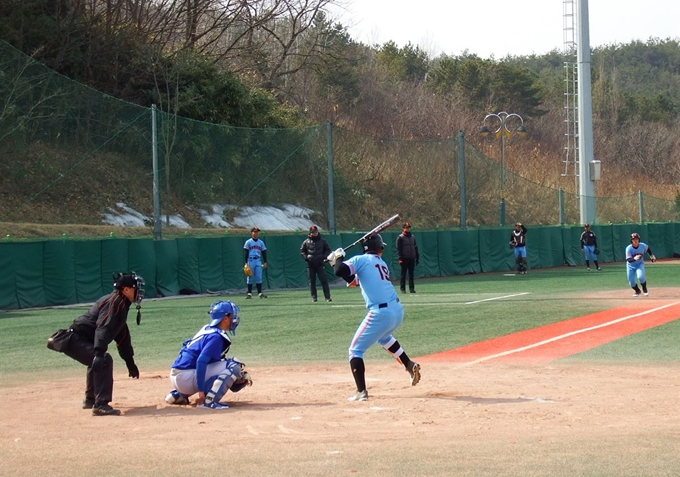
0,0,680,231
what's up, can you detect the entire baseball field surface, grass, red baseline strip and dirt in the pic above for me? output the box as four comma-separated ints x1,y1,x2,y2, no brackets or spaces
0,260,680,477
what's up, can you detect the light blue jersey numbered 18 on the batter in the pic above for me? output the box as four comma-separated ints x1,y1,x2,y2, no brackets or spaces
344,253,397,309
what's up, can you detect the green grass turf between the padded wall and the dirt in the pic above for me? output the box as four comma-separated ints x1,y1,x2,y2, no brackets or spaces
0,262,680,385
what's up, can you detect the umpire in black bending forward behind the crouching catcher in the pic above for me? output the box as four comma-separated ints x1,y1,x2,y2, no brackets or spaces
56,272,144,416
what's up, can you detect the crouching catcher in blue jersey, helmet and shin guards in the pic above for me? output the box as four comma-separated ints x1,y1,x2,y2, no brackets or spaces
165,301,253,409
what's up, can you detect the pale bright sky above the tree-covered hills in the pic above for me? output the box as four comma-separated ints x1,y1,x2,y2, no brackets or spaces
331,0,680,59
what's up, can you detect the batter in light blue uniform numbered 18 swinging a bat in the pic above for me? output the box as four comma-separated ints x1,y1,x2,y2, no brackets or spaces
328,234,420,401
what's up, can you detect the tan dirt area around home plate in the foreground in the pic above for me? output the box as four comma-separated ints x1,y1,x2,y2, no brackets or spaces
0,291,680,476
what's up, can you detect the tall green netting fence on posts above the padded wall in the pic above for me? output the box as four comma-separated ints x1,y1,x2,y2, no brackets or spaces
0,43,680,231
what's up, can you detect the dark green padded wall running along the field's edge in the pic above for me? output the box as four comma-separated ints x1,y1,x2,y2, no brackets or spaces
0,223,680,310
